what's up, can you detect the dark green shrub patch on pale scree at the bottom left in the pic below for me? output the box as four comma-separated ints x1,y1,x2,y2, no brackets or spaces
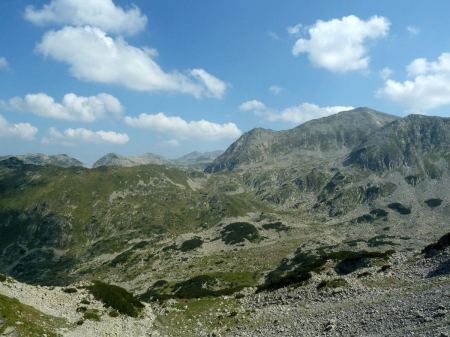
87,281,144,317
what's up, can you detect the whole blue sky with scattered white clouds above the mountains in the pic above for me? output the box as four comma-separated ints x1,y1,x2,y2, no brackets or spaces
0,0,450,166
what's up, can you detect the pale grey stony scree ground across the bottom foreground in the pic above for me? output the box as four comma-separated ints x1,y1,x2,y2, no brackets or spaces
0,245,450,337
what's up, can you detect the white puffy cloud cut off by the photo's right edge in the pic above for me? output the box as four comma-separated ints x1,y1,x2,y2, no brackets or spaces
376,53,450,113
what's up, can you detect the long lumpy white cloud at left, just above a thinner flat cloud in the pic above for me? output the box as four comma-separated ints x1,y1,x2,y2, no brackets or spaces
7,93,124,122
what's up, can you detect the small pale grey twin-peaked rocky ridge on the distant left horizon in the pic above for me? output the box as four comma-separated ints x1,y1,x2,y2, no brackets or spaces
93,153,176,168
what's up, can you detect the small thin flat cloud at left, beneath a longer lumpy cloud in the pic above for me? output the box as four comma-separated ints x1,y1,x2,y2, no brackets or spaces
42,128,130,146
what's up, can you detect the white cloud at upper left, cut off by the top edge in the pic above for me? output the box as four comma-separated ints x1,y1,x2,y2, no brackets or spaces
25,0,147,35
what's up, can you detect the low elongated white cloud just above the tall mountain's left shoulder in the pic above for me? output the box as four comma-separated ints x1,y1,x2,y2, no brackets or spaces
240,101,354,124
